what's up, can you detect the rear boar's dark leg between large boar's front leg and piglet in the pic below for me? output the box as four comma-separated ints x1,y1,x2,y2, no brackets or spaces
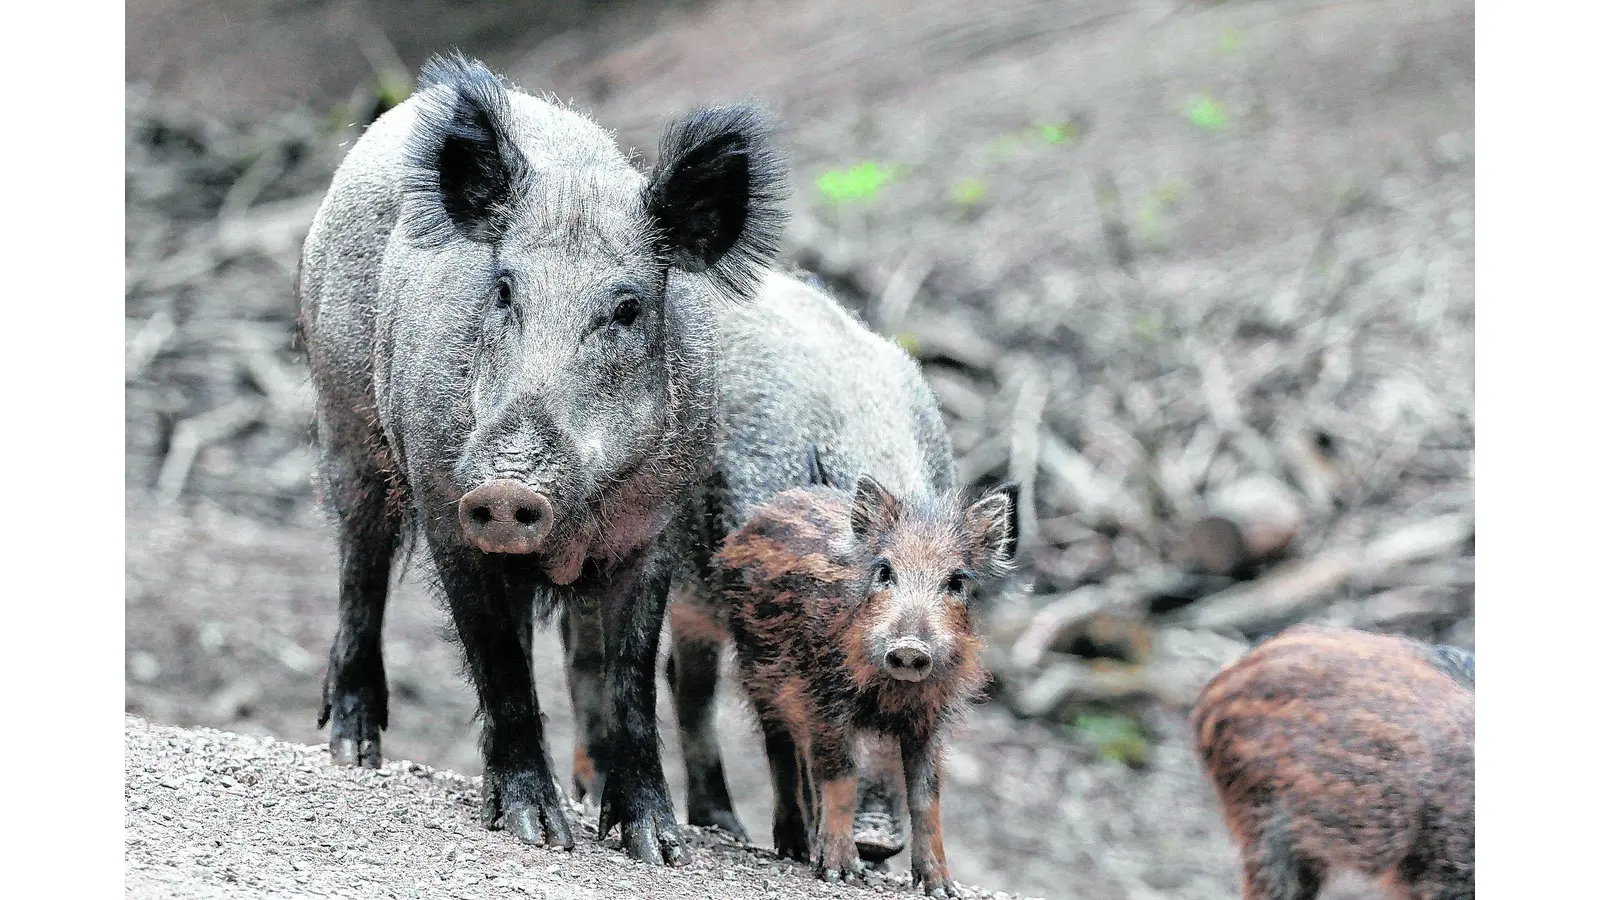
667,601,749,841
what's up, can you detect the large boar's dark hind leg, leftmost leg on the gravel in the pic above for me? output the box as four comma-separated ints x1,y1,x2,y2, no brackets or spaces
317,463,400,769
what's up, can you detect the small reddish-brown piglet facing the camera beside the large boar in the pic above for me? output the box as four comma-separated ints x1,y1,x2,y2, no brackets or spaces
717,476,1016,897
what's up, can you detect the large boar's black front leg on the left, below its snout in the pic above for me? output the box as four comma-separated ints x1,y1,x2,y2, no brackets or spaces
430,541,573,850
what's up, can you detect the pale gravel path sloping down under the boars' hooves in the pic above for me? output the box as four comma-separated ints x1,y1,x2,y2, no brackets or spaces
125,716,1049,900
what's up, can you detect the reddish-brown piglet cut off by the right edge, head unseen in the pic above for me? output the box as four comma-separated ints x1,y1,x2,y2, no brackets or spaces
1190,626,1474,900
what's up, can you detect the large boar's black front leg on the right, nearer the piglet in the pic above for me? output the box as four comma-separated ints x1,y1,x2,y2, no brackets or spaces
595,549,690,866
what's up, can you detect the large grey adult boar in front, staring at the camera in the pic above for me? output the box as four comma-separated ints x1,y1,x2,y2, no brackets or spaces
298,54,786,863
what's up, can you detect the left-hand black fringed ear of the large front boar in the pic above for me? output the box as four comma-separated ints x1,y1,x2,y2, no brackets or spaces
403,53,531,245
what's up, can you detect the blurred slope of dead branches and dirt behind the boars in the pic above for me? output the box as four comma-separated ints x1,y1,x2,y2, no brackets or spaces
126,0,1474,900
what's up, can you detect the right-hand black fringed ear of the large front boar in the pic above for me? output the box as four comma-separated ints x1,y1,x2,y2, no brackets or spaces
645,104,789,299
